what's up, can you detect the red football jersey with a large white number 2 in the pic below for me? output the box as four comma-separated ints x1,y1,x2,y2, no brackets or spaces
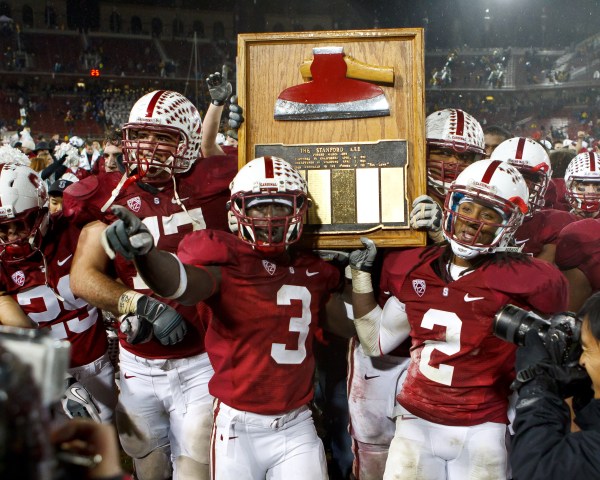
383,247,568,426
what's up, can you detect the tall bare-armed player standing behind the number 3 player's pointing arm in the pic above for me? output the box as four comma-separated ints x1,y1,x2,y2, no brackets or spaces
64,90,237,480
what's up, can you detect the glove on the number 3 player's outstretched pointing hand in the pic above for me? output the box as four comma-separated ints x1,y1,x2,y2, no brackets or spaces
101,205,154,260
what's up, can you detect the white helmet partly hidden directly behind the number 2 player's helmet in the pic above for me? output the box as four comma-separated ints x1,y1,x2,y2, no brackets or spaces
490,137,552,215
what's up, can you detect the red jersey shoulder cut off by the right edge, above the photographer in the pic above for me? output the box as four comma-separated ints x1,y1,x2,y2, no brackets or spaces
555,218,600,292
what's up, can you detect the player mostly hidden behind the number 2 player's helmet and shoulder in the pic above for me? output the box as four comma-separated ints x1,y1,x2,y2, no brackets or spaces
491,137,576,263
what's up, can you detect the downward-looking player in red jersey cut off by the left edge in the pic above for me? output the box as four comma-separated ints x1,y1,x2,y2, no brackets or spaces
0,163,117,423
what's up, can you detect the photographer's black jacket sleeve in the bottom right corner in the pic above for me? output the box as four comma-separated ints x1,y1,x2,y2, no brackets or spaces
511,382,600,480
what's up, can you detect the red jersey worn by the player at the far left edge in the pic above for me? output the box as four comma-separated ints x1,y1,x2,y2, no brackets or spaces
0,215,108,367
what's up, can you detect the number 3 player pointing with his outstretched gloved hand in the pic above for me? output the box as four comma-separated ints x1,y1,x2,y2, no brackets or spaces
105,157,353,480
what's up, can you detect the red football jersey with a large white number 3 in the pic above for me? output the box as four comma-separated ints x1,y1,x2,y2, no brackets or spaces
178,230,340,415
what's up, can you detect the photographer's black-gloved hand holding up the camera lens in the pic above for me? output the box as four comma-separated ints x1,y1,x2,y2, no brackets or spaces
511,329,588,398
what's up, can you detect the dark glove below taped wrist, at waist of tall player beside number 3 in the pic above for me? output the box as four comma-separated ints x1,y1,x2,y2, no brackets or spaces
135,295,187,345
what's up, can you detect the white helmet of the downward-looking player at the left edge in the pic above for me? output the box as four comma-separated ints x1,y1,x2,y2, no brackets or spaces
0,163,48,262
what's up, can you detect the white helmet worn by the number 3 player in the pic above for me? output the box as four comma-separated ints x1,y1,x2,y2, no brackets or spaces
228,157,309,253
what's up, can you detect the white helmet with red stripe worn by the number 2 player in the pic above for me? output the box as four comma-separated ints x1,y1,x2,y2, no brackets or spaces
442,160,529,259
